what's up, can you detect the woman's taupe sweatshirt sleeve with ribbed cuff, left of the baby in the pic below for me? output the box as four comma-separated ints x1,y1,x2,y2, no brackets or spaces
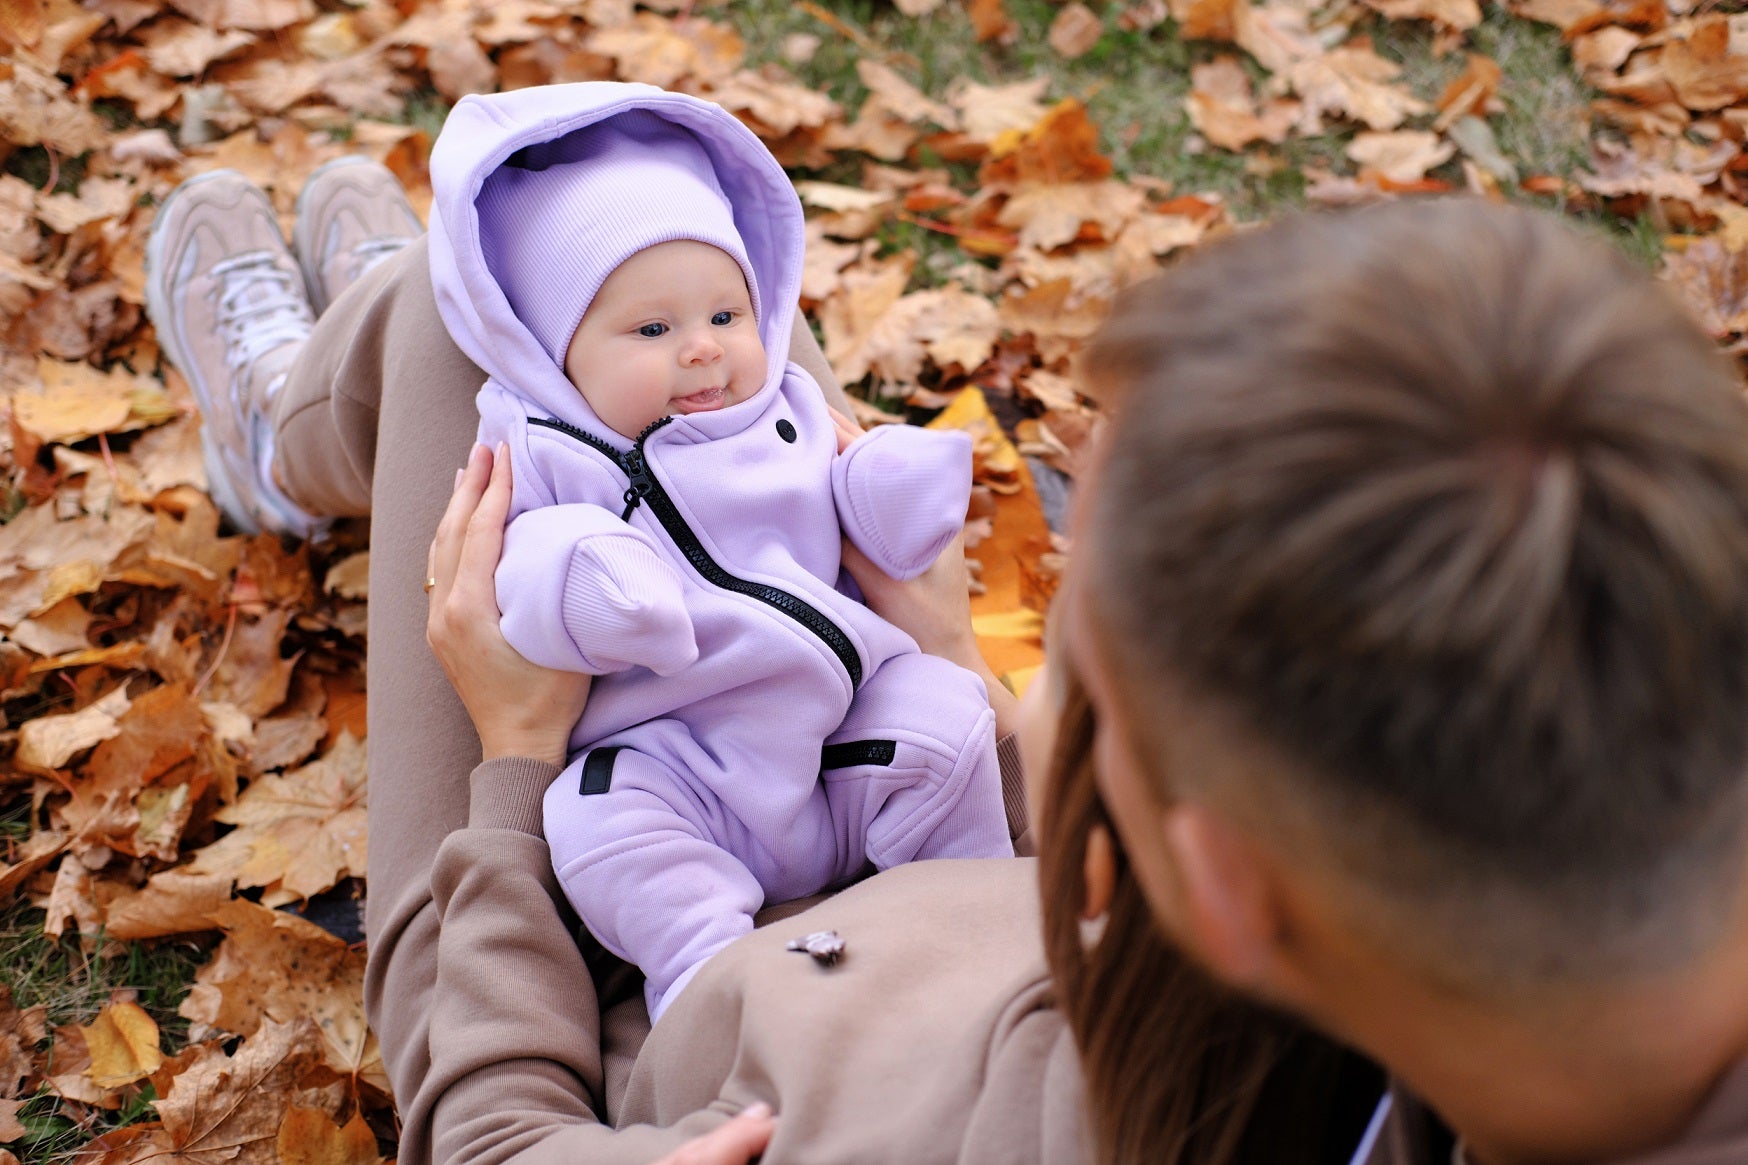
427,759,751,1165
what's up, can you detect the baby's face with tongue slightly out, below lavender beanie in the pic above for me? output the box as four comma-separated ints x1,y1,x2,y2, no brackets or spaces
565,240,766,437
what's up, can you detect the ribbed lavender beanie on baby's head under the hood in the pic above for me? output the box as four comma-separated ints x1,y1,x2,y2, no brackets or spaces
475,110,760,367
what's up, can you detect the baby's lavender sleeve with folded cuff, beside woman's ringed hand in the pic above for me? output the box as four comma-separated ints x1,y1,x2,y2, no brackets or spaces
496,502,697,675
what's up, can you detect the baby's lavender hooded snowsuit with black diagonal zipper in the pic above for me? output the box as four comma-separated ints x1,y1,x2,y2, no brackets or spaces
430,82,1012,1015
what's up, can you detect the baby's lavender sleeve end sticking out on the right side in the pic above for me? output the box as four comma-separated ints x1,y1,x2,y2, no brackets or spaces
832,425,972,579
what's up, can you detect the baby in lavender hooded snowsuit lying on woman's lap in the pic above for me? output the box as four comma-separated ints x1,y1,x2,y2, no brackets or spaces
430,82,1012,1016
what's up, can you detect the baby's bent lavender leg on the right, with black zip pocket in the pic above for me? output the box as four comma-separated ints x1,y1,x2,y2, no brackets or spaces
822,654,1014,869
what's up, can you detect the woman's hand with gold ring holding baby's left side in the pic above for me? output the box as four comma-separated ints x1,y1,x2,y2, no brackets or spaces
425,444,589,764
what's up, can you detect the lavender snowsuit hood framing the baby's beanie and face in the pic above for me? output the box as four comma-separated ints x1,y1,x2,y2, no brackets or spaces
430,82,804,448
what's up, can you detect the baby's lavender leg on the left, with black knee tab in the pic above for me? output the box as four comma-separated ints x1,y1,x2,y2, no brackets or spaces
545,747,764,1018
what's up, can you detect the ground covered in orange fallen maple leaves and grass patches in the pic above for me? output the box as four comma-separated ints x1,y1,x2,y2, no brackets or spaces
0,0,1748,1165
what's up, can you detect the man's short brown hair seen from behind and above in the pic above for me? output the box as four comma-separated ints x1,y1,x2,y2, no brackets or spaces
1082,201,1748,985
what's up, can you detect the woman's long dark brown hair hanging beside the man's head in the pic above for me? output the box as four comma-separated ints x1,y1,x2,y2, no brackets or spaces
1038,665,1383,1165
